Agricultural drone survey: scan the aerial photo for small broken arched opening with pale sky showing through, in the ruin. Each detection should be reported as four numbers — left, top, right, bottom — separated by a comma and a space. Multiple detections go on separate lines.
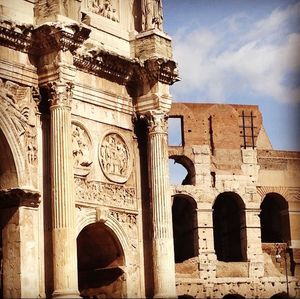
169, 155, 195, 185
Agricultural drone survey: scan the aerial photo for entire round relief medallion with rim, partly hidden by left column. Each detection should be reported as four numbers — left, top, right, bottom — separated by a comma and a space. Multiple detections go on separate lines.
72, 122, 93, 176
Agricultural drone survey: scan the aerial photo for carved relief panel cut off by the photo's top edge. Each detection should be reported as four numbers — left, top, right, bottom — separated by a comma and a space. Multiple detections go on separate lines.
84, 0, 120, 22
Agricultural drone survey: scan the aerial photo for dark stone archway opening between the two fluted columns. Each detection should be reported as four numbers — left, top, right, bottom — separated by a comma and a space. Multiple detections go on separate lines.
77, 222, 126, 298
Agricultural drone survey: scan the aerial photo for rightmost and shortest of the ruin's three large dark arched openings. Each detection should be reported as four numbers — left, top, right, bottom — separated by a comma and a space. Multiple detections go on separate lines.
260, 193, 291, 243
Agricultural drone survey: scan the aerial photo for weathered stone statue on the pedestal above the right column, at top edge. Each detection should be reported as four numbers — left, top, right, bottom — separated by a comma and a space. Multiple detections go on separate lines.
142, 0, 163, 31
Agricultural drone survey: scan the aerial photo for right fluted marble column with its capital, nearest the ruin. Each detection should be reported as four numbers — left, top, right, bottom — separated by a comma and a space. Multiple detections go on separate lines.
147, 111, 176, 298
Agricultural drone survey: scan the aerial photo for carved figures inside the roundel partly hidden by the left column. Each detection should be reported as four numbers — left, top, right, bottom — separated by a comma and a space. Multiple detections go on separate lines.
72, 124, 93, 171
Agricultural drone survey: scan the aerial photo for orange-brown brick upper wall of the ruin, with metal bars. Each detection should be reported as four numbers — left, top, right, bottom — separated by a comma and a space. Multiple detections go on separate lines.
170, 103, 264, 150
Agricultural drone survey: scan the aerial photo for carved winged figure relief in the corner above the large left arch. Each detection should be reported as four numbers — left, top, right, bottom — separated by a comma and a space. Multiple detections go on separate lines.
0, 79, 37, 164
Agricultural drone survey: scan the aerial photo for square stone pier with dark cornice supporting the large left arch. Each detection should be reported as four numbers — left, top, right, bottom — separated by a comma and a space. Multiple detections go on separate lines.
0, 188, 40, 298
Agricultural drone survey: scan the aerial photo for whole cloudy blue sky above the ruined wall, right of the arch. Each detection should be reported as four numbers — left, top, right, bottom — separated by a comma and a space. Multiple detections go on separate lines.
163, 0, 300, 155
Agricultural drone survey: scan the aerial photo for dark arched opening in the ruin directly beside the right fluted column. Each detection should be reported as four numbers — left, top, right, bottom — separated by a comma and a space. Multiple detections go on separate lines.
172, 195, 198, 263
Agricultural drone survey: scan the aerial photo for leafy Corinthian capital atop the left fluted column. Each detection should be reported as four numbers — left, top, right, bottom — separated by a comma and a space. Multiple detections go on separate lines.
47, 81, 74, 107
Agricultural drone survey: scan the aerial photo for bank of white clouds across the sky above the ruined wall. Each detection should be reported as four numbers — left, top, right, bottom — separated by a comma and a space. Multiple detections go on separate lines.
173, 2, 300, 102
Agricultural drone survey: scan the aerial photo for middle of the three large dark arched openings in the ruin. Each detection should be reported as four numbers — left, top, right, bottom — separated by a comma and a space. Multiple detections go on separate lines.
213, 192, 247, 262
